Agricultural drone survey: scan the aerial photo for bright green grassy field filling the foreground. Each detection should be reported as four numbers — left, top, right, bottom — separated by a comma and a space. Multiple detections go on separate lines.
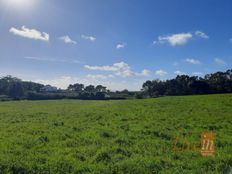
0, 95, 232, 174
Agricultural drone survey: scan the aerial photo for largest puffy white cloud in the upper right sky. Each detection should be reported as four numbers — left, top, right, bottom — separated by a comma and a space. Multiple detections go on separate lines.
153, 33, 193, 46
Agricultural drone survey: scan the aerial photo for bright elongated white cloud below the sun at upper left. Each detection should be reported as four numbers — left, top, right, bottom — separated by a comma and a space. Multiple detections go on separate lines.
9, 26, 49, 41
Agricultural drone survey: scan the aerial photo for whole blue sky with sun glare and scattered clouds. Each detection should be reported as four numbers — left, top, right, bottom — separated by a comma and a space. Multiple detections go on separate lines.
0, 0, 232, 90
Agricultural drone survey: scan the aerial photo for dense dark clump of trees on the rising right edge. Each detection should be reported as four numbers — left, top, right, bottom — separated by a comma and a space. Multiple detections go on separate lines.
141, 69, 232, 98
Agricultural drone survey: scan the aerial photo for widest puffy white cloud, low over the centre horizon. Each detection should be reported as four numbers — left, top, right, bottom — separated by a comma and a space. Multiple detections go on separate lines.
84, 62, 150, 77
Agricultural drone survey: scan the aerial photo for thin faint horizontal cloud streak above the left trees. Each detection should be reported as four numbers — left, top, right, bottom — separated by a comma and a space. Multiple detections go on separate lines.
24, 56, 83, 64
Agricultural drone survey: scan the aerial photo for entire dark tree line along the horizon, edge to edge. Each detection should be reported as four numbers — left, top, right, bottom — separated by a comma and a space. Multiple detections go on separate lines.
0, 70, 232, 100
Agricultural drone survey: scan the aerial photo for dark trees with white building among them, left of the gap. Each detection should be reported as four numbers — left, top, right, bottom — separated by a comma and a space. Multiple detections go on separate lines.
0, 76, 114, 100
